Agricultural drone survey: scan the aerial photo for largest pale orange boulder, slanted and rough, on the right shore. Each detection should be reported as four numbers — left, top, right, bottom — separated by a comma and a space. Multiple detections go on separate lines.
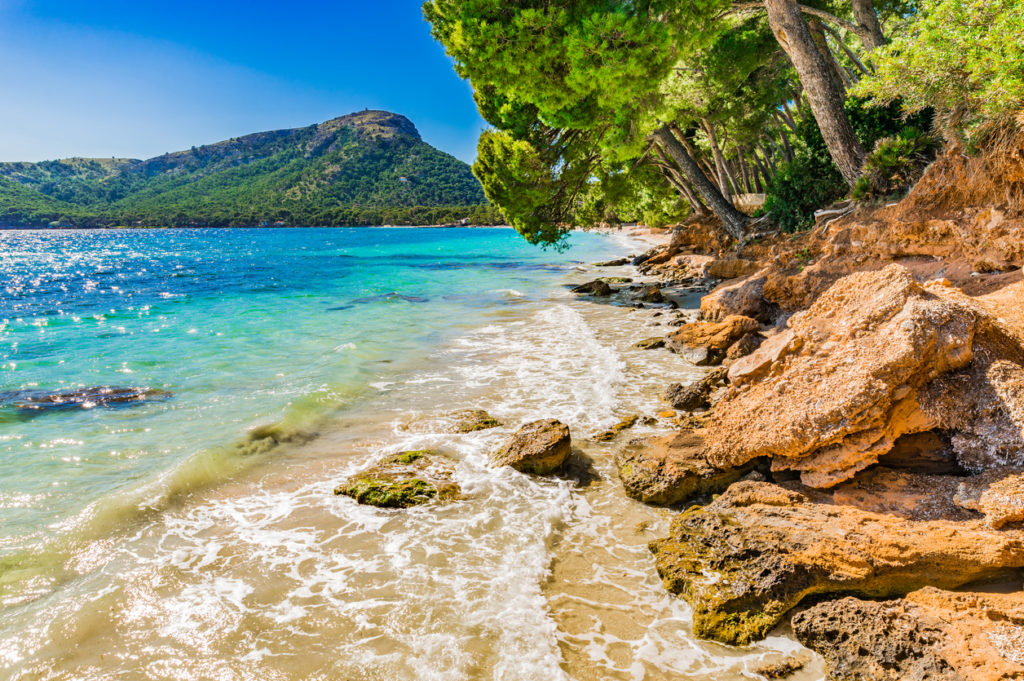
700, 265, 1024, 487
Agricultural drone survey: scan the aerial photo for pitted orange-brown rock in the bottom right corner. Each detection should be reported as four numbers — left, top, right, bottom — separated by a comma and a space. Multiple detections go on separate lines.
793, 588, 1024, 681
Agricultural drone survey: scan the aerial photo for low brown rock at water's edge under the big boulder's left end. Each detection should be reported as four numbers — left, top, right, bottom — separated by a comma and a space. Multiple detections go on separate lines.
615, 433, 754, 506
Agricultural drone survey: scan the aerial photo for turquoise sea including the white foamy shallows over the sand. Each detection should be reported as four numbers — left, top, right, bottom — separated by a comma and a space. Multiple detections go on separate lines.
0, 228, 820, 681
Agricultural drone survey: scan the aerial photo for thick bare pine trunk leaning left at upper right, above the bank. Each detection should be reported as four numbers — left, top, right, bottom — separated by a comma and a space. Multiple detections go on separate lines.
765, 0, 865, 186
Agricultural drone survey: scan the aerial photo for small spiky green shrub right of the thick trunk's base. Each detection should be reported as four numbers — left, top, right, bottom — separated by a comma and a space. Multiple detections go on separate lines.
852, 127, 938, 200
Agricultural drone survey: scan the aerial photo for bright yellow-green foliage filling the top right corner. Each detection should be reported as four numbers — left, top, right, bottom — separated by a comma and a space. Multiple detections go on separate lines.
856, 0, 1024, 136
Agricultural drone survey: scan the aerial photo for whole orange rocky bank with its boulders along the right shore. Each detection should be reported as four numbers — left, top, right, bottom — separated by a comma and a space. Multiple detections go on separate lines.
623, 130, 1024, 681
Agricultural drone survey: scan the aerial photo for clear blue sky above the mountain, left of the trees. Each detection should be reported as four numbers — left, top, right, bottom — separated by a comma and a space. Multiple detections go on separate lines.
0, 0, 484, 161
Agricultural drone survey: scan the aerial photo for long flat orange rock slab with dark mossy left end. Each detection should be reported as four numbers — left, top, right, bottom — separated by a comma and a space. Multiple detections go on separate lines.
650, 481, 1024, 645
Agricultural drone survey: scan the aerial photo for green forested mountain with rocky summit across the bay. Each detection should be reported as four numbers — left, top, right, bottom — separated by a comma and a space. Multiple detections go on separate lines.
0, 111, 498, 226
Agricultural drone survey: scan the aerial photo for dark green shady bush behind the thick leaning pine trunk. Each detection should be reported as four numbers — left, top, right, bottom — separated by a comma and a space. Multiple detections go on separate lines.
764, 98, 932, 231
